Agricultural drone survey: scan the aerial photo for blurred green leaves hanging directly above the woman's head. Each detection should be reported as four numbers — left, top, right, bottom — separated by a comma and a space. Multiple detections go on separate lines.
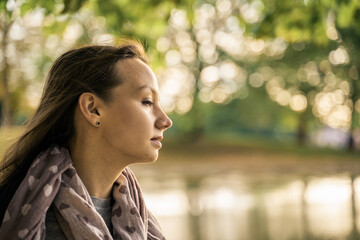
87, 0, 194, 48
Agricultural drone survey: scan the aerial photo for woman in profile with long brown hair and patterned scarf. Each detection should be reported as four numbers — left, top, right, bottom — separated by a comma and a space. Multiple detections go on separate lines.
0, 43, 172, 239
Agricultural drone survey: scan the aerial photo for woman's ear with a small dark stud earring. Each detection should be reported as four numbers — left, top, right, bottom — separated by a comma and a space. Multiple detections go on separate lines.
78, 93, 100, 126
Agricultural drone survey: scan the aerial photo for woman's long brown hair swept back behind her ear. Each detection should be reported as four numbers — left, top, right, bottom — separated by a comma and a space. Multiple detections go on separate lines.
0, 41, 147, 219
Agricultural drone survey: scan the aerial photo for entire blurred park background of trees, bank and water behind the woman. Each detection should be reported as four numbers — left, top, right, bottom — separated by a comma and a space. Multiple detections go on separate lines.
0, 0, 360, 240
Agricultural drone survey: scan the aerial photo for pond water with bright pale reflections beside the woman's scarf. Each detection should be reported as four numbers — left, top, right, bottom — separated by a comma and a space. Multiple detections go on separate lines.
139, 173, 360, 240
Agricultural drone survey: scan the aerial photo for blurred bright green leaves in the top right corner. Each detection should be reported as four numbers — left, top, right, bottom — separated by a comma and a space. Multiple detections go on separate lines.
256, 0, 360, 42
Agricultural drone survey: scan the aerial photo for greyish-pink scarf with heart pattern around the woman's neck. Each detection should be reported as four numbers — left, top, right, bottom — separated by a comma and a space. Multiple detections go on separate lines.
0, 146, 165, 240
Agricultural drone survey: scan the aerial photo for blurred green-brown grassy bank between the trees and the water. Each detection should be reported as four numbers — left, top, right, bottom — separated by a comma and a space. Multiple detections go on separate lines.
0, 127, 360, 175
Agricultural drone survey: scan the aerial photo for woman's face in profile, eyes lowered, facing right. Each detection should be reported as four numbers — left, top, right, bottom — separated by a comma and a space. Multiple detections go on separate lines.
99, 58, 172, 164
